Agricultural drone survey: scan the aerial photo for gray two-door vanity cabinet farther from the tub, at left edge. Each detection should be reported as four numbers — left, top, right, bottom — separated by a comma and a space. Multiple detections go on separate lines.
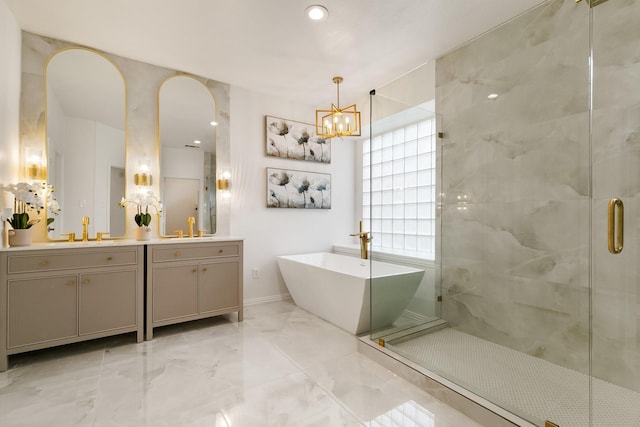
0, 244, 144, 371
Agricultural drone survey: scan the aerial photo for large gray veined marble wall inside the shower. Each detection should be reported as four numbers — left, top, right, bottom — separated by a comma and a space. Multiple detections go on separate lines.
436, 0, 640, 391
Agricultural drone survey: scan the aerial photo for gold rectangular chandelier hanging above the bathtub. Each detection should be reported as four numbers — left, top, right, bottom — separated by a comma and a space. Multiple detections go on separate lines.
316, 77, 360, 139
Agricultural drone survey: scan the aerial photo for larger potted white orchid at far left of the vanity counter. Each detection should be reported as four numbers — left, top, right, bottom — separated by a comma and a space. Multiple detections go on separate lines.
3, 182, 60, 246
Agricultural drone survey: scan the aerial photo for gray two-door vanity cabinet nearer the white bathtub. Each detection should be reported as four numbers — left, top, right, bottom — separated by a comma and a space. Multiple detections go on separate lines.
146, 240, 243, 340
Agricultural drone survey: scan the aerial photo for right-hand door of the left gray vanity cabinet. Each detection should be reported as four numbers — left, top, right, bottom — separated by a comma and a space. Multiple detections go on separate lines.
80, 270, 137, 335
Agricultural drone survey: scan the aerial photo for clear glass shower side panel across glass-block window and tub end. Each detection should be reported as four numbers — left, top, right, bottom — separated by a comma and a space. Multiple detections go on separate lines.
362, 90, 441, 339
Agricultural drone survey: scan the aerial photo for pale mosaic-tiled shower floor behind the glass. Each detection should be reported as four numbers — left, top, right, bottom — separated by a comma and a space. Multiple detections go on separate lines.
387, 328, 640, 427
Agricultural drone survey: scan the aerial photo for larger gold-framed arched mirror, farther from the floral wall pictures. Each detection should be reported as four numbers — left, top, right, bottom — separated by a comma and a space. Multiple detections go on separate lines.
45, 48, 126, 239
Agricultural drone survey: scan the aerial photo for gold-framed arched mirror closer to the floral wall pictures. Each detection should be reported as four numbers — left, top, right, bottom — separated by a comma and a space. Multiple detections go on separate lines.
158, 76, 216, 235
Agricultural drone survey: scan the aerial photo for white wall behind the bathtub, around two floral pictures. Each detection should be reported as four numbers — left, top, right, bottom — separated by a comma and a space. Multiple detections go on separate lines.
230, 87, 357, 303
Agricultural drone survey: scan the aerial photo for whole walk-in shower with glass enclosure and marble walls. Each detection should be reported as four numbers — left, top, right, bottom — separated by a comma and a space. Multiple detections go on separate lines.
363, 0, 640, 427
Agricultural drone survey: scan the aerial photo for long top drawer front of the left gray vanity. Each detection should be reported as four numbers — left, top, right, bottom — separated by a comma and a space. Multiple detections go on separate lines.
7, 249, 138, 274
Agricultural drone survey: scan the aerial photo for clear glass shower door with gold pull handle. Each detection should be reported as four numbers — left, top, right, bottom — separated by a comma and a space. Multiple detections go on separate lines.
591, 0, 640, 427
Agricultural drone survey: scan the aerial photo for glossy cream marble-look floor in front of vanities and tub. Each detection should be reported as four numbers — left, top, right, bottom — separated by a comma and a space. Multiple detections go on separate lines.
0, 301, 479, 427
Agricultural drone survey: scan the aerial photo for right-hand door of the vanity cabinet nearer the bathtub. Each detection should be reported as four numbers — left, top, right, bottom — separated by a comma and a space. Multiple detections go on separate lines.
200, 261, 240, 313
